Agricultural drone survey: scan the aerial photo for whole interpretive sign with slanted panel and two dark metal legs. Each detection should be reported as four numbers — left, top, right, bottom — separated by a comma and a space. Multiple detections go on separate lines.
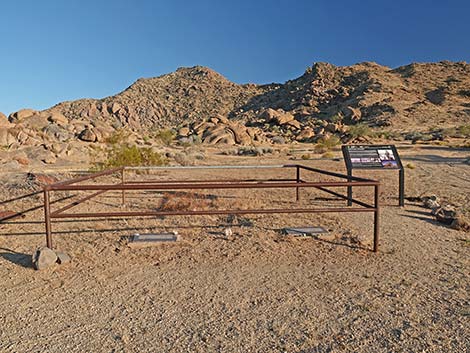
341, 145, 405, 207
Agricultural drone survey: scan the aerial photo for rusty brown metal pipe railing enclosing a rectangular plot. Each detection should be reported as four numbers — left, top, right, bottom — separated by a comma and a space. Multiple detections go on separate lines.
43, 164, 380, 252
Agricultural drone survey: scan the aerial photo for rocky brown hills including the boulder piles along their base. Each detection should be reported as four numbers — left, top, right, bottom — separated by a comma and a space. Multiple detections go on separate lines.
0, 61, 470, 166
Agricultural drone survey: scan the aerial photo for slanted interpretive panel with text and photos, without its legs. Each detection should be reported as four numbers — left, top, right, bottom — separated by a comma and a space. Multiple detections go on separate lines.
342, 145, 403, 169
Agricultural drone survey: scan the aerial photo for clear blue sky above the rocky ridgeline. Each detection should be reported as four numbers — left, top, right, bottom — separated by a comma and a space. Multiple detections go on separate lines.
0, 0, 470, 114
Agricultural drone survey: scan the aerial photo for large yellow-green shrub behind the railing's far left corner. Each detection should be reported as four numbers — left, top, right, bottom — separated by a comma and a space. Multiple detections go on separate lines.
92, 144, 167, 170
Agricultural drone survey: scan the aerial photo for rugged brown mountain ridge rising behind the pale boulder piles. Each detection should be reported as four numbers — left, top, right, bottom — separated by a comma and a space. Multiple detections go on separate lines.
46, 61, 470, 130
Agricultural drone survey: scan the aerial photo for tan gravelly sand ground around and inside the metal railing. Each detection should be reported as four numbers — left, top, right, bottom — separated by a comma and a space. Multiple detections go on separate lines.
0, 144, 470, 352
